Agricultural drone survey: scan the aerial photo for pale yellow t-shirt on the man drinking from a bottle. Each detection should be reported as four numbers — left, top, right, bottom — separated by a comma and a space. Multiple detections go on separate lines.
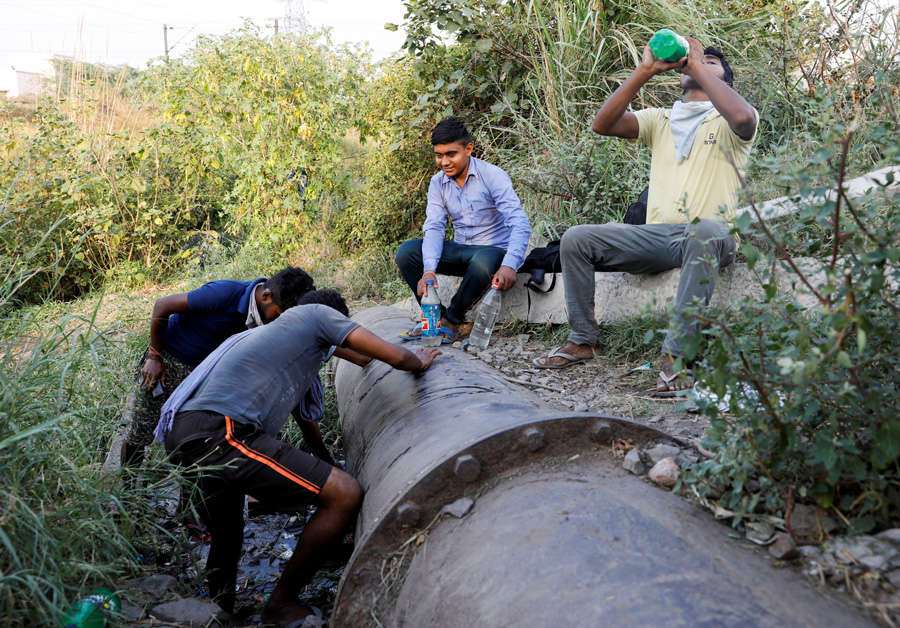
635, 109, 759, 224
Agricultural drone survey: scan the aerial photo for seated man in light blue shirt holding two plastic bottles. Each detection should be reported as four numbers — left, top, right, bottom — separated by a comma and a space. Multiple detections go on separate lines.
396, 118, 531, 339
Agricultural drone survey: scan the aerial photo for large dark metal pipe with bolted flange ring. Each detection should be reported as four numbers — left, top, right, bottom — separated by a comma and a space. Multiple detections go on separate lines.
332, 307, 866, 627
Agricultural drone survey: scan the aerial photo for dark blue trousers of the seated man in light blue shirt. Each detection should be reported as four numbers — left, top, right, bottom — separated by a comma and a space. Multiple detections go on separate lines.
395, 238, 506, 325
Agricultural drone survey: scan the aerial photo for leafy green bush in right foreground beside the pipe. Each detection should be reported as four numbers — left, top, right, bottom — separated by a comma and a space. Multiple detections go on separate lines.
686, 79, 900, 532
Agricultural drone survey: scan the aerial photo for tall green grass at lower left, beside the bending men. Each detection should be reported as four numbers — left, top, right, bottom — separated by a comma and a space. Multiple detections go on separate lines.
0, 298, 142, 626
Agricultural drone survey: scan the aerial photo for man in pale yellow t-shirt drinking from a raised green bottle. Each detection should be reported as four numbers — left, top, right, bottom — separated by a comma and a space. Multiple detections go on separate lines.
534, 37, 759, 396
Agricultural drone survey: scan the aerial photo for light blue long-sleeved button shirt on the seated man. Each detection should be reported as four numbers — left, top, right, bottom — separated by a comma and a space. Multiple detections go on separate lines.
422, 157, 531, 271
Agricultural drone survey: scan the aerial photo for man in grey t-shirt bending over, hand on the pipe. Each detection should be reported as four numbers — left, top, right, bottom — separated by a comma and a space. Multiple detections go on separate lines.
165, 290, 440, 624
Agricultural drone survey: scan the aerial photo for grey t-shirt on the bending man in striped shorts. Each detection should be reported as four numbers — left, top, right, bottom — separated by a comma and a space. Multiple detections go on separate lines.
180, 304, 359, 436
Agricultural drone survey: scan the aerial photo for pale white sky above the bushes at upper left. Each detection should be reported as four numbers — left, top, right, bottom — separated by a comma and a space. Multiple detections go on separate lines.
0, 0, 404, 68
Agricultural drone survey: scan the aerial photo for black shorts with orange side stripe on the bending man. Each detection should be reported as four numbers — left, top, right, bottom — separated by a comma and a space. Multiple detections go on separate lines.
166, 411, 332, 510
